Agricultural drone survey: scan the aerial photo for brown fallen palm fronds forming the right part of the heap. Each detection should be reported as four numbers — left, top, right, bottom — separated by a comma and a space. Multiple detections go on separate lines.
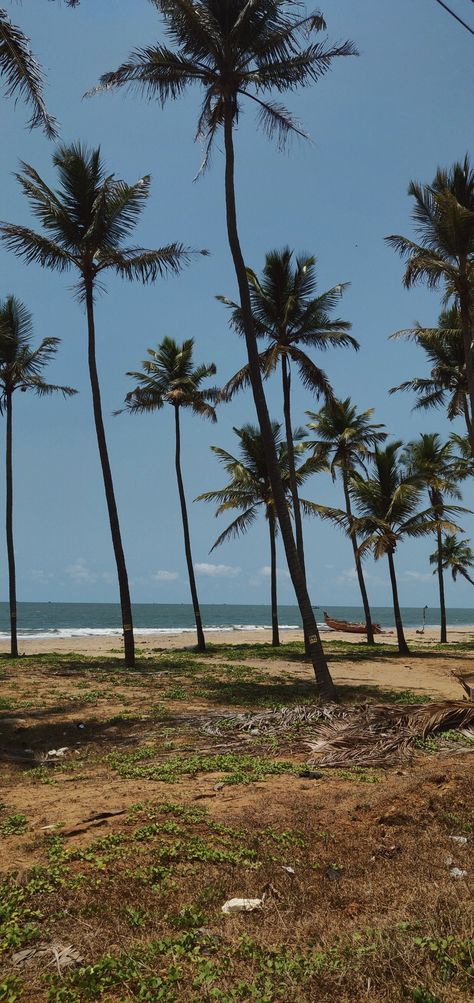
308, 701, 474, 767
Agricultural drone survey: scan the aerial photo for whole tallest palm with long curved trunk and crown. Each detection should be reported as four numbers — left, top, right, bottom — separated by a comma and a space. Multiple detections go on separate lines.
91, 0, 356, 700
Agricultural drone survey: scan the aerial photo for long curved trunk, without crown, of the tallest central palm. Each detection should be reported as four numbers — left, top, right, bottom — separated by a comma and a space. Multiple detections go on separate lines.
224, 99, 337, 700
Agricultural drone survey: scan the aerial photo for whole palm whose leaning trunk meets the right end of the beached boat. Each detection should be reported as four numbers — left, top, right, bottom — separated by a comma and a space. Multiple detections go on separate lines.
307, 397, 387, 644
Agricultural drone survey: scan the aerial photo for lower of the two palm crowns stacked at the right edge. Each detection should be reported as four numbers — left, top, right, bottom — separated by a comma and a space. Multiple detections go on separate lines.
390, 305, 473, 435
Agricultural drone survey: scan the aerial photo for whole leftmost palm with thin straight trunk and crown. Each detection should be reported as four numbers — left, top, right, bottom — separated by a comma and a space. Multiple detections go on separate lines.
0, 296, 77, 658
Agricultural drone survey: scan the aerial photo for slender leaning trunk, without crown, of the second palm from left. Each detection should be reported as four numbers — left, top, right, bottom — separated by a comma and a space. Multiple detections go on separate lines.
84, 277, 135, 668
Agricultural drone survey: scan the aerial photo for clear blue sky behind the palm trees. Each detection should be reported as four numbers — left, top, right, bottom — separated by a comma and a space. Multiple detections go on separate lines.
0, 0, 474, 606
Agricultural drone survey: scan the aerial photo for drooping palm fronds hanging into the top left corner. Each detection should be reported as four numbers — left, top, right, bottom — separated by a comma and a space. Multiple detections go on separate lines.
0, 7, 57, 139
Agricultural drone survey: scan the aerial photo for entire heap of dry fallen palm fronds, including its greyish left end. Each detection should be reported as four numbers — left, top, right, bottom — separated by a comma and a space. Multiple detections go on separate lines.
202, 700, 474, 767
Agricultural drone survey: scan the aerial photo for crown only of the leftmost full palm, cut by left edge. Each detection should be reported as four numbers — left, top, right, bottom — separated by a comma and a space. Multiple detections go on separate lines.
0, 296, 77, 403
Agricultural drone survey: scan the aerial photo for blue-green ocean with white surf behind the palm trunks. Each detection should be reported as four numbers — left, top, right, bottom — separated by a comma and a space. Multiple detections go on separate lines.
0, 603, 474, 639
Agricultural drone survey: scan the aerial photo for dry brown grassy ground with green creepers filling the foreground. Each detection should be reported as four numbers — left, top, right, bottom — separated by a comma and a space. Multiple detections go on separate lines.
0, 645, 474, 1003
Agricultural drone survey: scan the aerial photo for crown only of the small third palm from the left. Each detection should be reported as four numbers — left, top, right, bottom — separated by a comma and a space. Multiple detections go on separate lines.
121, 338, 218, 421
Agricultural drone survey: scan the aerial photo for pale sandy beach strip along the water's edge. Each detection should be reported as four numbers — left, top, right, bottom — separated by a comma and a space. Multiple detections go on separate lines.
0, 624, 474, 657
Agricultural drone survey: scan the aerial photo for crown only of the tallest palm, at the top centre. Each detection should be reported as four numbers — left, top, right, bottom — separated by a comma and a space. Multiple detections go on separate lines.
95, 0, 356, 169
